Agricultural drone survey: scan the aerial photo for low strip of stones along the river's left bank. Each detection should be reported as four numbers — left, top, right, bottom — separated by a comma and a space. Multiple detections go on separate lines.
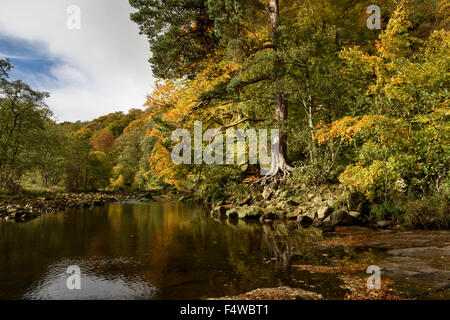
0, 192, 136, 222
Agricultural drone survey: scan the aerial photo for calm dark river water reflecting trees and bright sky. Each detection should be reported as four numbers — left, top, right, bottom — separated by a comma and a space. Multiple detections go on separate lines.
0, 203, 344, 299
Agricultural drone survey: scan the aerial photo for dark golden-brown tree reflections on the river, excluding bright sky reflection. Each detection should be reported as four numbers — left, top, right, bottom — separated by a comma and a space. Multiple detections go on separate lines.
0, 203, 324, 299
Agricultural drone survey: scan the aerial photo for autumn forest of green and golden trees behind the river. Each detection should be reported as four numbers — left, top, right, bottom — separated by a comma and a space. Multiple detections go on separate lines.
0, 0, 450, 228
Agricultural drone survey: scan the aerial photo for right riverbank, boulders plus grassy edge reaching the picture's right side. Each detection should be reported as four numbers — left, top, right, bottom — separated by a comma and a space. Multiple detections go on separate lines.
206, 184, 450, 232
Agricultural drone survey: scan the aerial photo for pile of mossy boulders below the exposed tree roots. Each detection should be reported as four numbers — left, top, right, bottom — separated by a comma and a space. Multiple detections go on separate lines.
211, 187, 396, 232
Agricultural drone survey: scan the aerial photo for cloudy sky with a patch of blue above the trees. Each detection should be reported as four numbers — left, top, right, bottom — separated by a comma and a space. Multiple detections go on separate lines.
0, 0, 154, 122
